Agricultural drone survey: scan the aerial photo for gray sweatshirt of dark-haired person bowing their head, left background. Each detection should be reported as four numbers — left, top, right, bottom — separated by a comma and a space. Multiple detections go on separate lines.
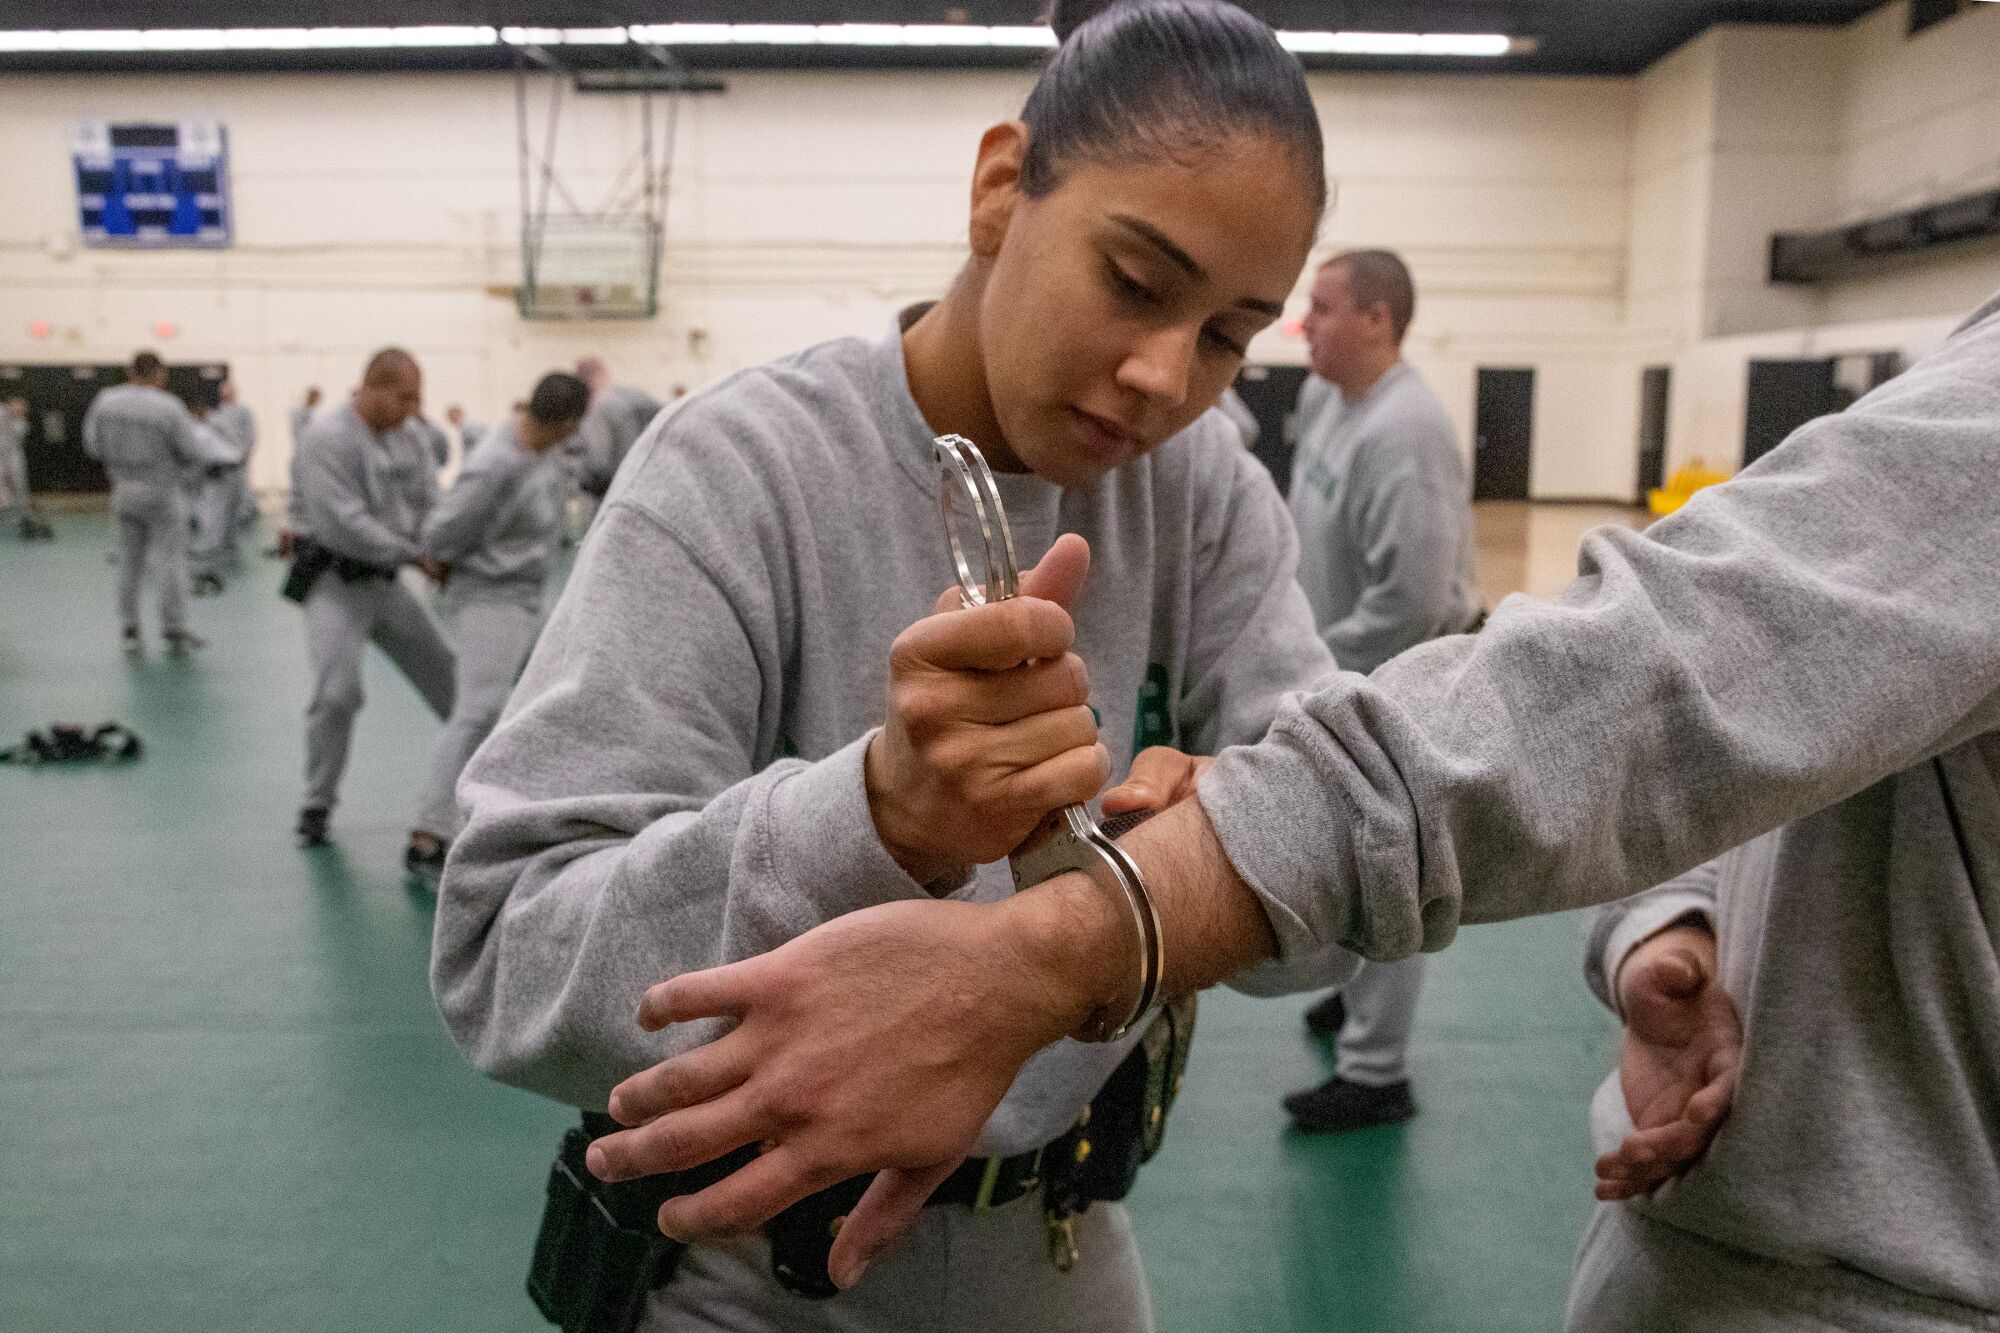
424, 422, 562, 606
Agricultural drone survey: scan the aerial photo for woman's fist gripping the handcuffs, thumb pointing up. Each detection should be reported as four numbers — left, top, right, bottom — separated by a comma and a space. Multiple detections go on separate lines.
866, 536, 1110, 885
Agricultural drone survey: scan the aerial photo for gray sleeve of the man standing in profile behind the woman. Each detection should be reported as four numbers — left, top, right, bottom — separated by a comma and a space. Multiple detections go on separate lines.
1324, 440, 1466, 671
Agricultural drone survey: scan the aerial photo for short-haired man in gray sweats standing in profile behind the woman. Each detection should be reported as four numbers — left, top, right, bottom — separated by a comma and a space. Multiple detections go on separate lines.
1284, 250, 1480, 1133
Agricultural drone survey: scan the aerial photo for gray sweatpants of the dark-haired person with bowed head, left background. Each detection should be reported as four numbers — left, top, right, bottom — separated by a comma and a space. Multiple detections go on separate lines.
416, 588, 542, 843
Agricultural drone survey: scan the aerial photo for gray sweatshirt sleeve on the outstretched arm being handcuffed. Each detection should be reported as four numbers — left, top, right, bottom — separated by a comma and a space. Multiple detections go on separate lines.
1200, 286, 2000, 959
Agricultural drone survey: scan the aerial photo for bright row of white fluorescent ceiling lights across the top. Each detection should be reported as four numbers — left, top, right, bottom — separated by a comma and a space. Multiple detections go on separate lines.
0, 24, 1534, 56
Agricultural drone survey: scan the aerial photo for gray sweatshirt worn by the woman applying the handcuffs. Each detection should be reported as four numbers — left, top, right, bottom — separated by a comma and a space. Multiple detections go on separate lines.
432, 324, 1332, 1153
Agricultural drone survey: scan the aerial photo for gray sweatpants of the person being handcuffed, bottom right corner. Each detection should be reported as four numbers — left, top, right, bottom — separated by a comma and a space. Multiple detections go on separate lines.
1566, 1203, 2000, 1333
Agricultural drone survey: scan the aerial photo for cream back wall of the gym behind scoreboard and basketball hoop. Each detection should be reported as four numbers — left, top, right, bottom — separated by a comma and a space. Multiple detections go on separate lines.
0, 63, 1632, 494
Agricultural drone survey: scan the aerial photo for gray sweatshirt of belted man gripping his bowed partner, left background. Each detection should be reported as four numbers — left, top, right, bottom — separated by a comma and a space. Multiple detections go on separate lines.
292, 402, 438, 568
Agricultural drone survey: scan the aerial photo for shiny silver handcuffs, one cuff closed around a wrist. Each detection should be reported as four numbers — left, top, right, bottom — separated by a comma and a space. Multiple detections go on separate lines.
936, 434, 1166, 1041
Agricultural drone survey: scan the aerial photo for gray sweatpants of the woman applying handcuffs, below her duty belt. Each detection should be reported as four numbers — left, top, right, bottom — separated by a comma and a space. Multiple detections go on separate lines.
640, 1193, 1152, 1333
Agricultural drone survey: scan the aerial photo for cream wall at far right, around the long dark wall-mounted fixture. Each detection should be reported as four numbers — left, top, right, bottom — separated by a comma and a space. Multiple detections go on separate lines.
1634, 0, 2000, 468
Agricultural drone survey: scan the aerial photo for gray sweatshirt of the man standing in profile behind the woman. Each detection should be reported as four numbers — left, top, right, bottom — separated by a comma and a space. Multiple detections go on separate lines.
1290, 360, 1480, 671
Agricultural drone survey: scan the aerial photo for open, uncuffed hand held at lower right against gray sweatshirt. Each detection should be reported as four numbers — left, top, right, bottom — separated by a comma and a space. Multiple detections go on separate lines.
1598, 927, 1744, 1201
